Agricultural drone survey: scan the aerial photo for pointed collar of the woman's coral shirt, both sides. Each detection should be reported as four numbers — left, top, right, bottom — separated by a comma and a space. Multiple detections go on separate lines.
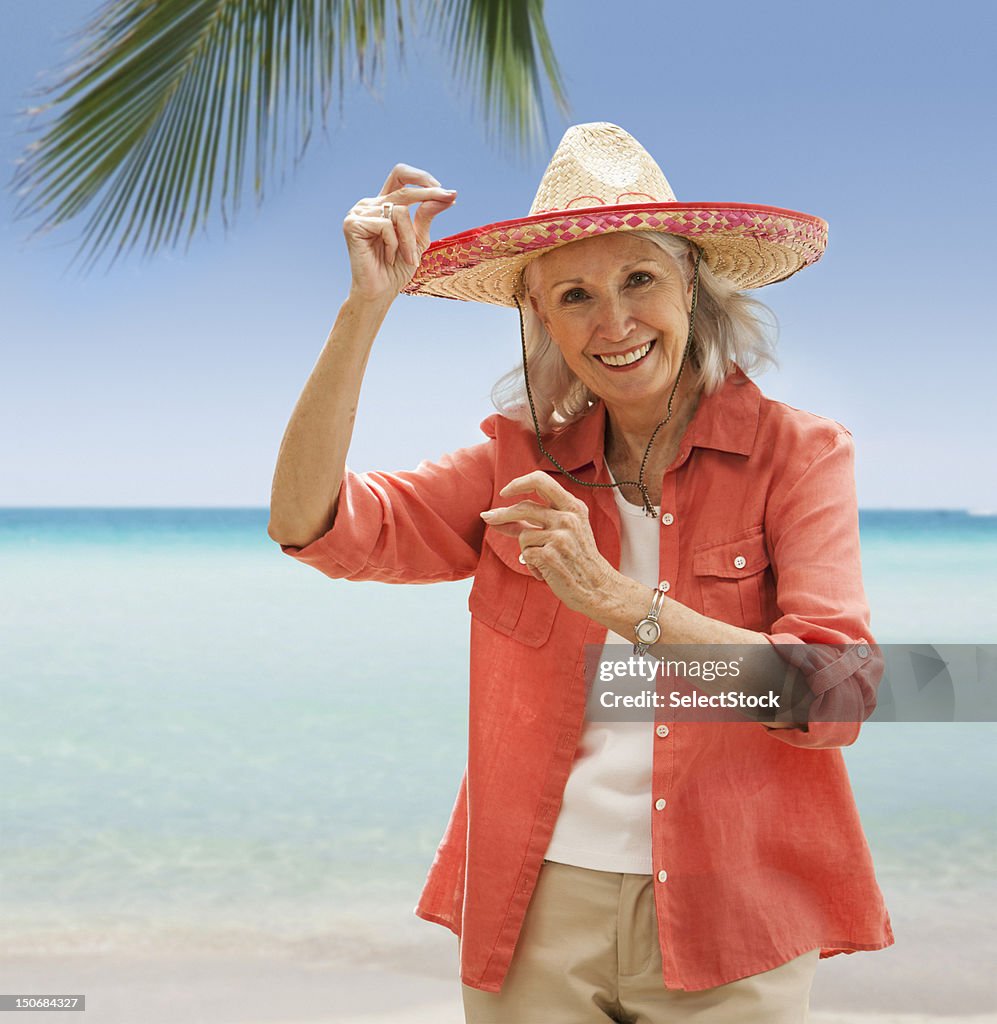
533, 367, 762, 472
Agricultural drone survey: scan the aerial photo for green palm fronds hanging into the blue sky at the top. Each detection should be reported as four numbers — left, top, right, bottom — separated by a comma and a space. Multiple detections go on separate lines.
12, 0, 566, 265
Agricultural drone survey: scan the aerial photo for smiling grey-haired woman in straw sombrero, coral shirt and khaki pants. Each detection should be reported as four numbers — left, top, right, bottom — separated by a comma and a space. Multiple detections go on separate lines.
269, 123, 894, 1024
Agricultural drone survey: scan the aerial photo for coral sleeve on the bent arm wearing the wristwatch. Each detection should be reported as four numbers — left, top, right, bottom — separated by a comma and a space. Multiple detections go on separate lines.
765, 427, 883, 748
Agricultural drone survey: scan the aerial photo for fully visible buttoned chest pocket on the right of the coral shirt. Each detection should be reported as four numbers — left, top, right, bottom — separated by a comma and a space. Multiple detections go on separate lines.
692, 526, 773, 630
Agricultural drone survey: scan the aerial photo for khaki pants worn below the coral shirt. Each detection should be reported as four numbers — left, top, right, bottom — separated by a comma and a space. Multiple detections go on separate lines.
461, 860, 820, 1024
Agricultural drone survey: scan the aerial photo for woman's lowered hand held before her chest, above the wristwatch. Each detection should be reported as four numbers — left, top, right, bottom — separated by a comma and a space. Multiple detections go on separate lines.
481, 470, 616, 611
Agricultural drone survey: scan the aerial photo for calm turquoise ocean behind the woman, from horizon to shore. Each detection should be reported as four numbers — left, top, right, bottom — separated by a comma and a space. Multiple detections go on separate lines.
0, 508, 997, 983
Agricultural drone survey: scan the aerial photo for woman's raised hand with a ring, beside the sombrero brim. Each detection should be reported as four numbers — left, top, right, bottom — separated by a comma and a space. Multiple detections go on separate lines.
343, 164, 457, 301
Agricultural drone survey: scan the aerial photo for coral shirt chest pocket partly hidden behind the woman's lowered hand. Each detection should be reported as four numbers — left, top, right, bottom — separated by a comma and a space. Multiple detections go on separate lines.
468, 529, 561, 647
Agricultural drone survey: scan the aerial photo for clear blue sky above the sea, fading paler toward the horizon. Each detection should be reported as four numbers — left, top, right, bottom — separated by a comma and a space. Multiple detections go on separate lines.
0, 0, 997, 508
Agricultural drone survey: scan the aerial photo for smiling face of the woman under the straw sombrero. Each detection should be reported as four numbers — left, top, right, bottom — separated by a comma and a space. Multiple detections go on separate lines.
526, 231, 692, 422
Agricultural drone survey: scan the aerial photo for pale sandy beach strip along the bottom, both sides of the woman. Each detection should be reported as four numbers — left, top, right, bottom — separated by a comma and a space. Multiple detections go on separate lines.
0, 919, 997, 1024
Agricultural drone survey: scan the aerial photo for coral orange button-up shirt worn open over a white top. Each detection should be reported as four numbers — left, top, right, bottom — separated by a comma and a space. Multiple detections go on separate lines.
281, 370, 894, 992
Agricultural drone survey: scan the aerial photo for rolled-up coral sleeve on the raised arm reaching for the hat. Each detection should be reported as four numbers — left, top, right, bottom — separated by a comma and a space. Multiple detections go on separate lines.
280, 440, 494, 584
